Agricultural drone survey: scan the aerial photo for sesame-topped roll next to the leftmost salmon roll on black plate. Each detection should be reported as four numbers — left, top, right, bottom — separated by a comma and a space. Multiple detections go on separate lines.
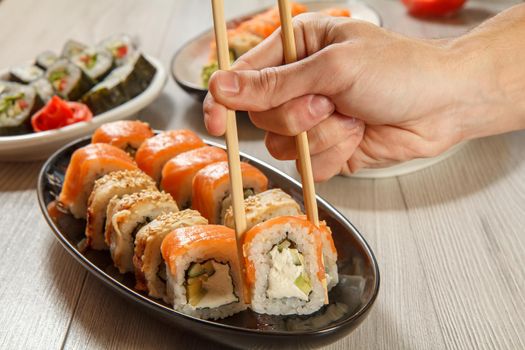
86, 170, 157, 250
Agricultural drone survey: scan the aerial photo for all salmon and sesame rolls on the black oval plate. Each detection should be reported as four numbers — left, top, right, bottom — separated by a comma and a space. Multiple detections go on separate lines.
56, 120, 339, 319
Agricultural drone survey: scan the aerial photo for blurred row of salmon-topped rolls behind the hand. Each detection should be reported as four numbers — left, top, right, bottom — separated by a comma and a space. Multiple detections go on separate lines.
201, 2, 351, 87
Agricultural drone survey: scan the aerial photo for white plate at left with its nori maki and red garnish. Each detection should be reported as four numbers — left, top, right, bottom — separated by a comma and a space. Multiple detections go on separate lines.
0, 34, 167, 161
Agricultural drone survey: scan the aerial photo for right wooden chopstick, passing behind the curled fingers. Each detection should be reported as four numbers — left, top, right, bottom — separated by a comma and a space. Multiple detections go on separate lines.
278, 0, 328, 304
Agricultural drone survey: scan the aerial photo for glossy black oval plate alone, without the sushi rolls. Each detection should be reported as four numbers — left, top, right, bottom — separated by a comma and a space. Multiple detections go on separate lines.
37, 137, 379, 348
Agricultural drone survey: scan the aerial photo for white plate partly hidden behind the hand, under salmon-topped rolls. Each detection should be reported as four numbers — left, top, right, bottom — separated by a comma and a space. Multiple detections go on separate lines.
171, 0, 381, 101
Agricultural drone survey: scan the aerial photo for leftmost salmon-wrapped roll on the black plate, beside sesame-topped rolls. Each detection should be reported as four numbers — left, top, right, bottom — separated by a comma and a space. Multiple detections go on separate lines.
58, 143, 137, 218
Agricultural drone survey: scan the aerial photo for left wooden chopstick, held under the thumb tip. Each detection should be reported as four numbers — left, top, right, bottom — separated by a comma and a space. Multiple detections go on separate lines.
211, 0, 250, 303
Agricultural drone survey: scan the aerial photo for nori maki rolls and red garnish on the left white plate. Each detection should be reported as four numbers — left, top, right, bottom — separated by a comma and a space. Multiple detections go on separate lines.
0, 34, 156, 136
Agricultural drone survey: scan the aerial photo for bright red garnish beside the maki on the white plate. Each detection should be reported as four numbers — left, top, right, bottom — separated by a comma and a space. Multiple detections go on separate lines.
31, 96, 93, 132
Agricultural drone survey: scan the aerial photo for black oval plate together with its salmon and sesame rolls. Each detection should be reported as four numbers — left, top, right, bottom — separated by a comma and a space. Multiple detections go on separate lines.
37, 120, 379, 348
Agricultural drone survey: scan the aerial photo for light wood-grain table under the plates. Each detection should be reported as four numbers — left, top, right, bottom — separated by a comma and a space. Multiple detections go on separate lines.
0, 0, 525, 349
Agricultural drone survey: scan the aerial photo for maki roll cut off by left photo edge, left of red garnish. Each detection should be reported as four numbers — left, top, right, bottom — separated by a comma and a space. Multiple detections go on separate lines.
0, 81, 39, 135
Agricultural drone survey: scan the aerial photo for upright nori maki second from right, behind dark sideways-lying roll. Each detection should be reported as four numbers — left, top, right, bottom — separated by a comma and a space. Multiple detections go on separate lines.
70, 49, 113, 81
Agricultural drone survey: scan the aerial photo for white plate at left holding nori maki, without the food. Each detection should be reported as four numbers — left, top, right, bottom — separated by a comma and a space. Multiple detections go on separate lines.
0, 56, 167, 161
